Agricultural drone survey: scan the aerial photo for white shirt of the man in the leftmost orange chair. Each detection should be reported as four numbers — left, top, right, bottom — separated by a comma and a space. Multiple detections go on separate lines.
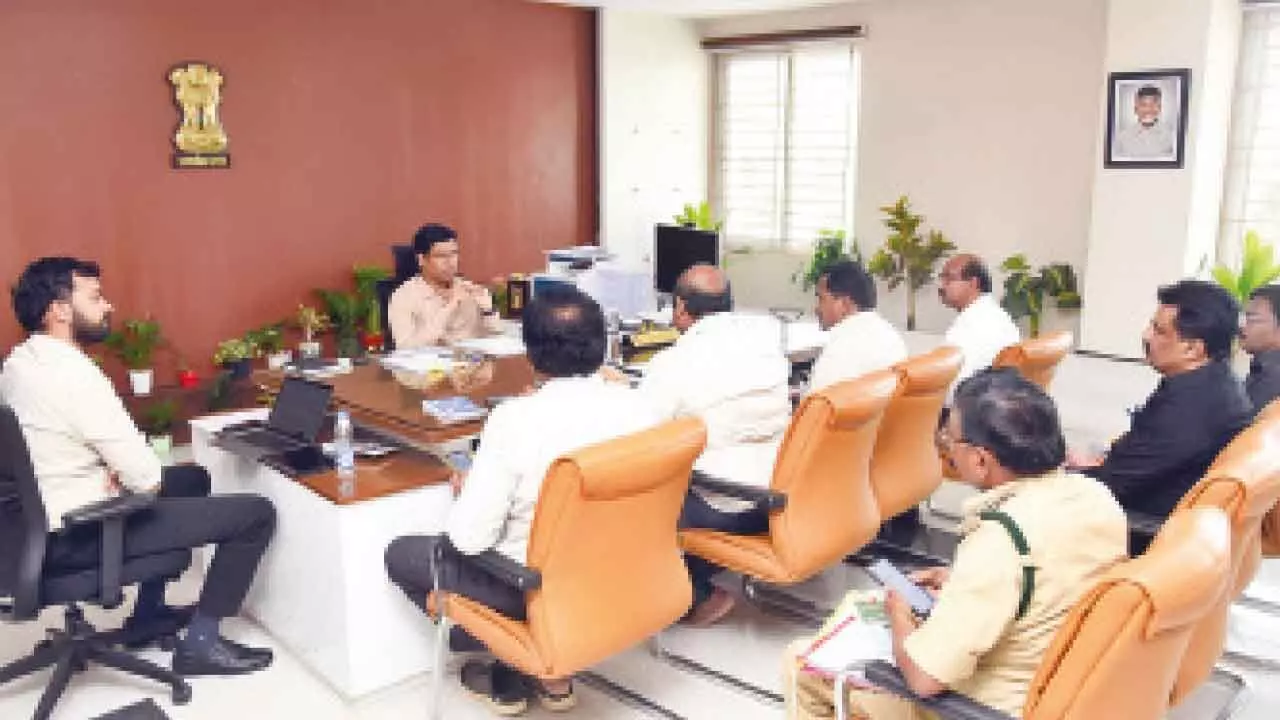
448, 375, 660, 564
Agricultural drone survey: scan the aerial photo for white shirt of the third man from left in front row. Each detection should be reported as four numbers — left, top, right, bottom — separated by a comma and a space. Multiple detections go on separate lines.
809, 310, 906, 392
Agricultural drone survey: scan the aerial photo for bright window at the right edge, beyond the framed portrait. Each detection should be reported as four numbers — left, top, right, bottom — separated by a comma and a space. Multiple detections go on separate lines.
1219, 6, 1280, 265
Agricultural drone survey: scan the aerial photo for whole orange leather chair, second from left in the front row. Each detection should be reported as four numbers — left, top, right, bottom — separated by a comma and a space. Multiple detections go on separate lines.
680, 370, 899, 584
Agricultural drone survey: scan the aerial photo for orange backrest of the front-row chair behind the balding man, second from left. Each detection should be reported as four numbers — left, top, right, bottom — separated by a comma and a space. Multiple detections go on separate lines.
769, 370, 899, 582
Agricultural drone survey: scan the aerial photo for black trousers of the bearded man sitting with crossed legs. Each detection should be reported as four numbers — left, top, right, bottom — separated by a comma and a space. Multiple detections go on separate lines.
45, 465, 275, 618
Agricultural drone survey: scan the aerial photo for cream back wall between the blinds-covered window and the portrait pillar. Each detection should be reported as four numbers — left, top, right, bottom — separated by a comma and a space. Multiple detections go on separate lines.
700, 0, 1107, 329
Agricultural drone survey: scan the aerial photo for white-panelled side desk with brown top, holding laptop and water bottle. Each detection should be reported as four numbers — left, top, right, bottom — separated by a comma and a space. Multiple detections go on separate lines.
191, 409, 453, 698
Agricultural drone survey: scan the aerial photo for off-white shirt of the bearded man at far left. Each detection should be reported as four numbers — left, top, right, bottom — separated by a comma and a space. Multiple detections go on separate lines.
0, 333, 161, 530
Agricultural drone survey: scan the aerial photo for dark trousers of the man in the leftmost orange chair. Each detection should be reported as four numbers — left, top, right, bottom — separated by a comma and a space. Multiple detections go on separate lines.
384, 536, 526, 651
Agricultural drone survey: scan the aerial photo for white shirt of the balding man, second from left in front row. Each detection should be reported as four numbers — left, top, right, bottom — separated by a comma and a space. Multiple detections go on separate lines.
640, 313, 791, 511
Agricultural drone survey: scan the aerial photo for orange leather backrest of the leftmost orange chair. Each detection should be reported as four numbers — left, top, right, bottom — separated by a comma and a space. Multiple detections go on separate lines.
519, 419, 707, 678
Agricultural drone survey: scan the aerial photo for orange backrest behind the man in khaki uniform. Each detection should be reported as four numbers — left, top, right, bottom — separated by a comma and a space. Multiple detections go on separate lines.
1023, 507, 1231, 720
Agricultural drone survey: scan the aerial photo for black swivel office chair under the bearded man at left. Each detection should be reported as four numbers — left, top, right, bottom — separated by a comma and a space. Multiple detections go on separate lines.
0, 406, 191, 720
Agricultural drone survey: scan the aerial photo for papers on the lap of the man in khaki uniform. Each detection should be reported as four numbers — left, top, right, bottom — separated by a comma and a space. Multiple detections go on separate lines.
800, 591, 893, 683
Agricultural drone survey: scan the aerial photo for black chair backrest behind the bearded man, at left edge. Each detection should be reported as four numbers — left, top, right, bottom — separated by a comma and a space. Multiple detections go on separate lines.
0, 405, 49, 620
